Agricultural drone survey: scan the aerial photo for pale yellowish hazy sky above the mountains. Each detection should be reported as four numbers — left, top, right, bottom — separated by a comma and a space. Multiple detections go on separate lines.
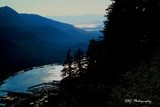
0, 0, 110, 16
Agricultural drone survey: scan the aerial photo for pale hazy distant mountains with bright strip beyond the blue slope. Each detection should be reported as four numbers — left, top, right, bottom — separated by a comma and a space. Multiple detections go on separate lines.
46, 14, 104, 31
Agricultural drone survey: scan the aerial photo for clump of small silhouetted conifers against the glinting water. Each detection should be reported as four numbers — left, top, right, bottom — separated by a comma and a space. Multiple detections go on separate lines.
62, 48, 88, 78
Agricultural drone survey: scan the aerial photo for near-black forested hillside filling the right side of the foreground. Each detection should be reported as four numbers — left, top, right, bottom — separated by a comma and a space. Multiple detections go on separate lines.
49, 0, 160, 107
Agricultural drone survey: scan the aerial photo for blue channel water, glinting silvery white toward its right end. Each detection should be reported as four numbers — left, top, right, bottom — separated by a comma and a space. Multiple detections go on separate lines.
0, 64, 63, 96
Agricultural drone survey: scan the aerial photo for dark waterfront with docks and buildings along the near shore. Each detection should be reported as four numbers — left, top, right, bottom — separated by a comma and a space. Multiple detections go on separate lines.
0, 80, 60, 106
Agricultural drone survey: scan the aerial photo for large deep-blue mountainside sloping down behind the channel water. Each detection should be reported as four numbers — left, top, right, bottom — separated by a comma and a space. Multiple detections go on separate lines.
0, 6, 102, 79
